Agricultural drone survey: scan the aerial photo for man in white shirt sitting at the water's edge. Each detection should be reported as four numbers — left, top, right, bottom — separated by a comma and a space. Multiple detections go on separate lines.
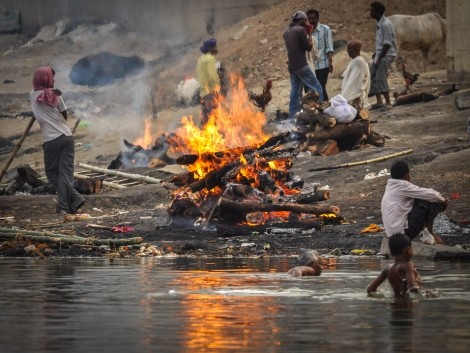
381, 161, 447, 244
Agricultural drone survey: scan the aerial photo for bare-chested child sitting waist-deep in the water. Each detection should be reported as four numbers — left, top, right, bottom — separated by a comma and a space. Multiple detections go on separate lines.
367, 233, 435, 298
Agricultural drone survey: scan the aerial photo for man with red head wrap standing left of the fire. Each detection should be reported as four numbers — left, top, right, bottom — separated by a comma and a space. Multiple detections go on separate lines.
30, 67, 85, 215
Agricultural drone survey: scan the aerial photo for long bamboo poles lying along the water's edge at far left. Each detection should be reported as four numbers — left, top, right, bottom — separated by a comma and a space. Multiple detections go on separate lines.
0, 227, 143, 246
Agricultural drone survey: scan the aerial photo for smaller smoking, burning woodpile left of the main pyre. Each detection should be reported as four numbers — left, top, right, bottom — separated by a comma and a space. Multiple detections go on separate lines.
108, 134, 175, 169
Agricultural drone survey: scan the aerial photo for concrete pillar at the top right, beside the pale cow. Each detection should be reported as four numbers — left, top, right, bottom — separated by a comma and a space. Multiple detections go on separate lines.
446, 0, 470, 82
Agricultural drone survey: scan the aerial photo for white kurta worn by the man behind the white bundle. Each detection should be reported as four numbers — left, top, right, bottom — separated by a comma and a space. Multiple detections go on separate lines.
341, 55, 370, 106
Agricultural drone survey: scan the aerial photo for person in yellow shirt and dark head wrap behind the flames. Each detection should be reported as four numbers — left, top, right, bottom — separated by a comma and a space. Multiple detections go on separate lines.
196, 38, 220, 127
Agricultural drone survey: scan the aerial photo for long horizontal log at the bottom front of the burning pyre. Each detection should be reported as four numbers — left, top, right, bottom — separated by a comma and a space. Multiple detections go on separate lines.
219, 198, 340, 215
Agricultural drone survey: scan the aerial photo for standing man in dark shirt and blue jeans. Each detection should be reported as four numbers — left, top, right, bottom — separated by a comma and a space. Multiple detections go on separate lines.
283, 11, 323, 118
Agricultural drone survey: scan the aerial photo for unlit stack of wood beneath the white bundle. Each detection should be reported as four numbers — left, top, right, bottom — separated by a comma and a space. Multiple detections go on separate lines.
296, 92, 385, 156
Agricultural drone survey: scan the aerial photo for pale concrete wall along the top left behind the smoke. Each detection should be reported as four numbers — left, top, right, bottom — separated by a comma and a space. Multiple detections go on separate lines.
0, 0, 278, 39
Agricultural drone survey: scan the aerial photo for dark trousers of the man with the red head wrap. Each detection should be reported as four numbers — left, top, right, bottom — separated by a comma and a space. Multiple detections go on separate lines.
44, 135, 85, 213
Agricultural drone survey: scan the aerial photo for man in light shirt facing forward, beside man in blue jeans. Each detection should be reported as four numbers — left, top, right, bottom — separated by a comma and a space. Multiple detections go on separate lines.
307, 10, 334, 101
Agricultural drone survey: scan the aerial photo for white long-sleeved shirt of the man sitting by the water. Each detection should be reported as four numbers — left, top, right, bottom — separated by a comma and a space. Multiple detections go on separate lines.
381, 179, 445, 237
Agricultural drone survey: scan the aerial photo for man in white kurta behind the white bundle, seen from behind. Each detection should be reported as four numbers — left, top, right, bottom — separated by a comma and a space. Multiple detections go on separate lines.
341, 40, 370, 108
